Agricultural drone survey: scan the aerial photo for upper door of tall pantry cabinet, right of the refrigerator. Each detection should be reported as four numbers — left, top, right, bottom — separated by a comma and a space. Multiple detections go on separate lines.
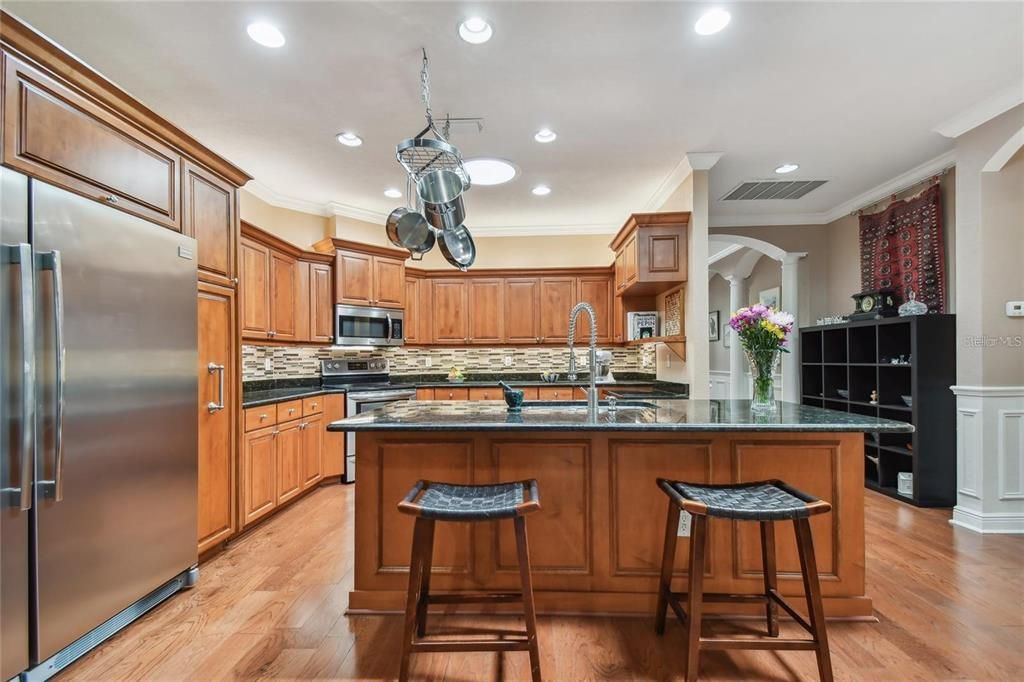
181, 161, 239, 286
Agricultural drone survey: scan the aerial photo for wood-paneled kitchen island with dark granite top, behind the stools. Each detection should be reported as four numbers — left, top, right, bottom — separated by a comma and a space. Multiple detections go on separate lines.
328, 400, 912, 619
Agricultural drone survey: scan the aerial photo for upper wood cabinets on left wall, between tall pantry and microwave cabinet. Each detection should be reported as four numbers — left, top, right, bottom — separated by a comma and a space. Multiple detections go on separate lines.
240, 223, 334, 343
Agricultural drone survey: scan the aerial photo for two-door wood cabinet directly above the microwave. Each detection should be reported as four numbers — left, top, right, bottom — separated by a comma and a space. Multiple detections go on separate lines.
335, 250, 406, 308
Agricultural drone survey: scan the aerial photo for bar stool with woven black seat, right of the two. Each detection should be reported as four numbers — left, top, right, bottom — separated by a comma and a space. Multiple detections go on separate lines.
654, 478, 833, 682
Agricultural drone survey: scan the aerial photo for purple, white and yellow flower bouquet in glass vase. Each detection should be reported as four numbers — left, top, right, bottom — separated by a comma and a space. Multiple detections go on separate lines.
729, 304, 794, 414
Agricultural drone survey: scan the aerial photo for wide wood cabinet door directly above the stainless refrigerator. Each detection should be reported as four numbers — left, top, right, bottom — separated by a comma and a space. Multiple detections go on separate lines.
3, 54, 181, 231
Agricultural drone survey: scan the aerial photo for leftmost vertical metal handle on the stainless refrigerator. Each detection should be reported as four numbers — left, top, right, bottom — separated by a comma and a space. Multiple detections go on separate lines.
4, 243, 36, 511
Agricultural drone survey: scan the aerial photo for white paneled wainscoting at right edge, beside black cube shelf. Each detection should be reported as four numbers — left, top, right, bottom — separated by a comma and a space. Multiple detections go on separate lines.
950, 386, 1024, 534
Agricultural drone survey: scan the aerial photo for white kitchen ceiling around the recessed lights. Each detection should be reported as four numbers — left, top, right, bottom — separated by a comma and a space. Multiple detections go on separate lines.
4, 2, 1024, 231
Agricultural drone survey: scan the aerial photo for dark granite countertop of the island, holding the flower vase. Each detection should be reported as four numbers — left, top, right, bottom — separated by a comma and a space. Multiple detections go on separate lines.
327, 399, 913, 433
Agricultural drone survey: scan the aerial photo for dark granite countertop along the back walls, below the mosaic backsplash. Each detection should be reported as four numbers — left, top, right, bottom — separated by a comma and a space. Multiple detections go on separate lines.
242, 373, 688, 408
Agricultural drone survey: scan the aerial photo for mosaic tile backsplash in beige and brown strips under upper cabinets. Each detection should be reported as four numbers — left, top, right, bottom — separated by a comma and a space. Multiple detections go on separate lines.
242, 345, 655, 381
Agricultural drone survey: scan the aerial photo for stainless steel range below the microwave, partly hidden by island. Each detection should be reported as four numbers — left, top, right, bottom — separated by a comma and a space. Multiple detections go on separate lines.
321, 358, 416, 483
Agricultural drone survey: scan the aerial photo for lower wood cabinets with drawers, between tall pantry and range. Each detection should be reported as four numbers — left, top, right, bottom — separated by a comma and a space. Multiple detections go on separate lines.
242, 403, 325, 525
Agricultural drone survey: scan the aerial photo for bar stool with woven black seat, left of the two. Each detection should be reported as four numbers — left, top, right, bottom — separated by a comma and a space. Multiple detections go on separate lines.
398, 480, 541, 682
